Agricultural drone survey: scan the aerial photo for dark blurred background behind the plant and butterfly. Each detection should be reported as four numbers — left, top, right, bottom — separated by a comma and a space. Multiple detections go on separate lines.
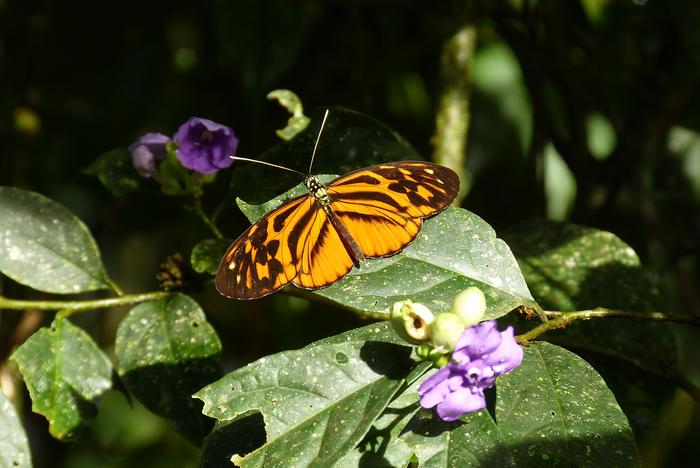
0, 0, 700, 467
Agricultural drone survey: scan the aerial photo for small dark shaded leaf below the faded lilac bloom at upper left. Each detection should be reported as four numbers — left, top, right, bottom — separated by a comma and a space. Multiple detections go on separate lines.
83, 148, 141, 197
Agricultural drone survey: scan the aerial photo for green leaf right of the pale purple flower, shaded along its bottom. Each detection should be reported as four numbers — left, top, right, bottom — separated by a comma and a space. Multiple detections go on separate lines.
496, 342, 640, 466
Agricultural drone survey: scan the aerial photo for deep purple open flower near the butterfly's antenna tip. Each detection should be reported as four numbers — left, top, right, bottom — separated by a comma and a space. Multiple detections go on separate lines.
173, 117, 238, 174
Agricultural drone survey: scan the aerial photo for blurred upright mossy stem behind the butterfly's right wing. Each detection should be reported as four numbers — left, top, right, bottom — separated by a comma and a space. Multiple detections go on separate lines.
432, 22, 476, 205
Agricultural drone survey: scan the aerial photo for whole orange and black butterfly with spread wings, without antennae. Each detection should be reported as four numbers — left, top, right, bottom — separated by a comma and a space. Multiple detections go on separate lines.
216, 161, 459, 299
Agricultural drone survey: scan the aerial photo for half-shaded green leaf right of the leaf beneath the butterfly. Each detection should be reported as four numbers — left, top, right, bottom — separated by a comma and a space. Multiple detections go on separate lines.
503, 220, 658, 310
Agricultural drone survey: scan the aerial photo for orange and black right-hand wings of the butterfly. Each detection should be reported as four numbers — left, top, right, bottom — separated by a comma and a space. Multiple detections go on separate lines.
328, 161, 459, 258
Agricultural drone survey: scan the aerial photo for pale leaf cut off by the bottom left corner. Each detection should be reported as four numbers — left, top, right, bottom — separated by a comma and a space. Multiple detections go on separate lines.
0, 392, 32, 468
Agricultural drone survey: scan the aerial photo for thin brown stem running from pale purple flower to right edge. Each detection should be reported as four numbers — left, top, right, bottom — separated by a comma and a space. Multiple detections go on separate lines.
517, 307, 700, 344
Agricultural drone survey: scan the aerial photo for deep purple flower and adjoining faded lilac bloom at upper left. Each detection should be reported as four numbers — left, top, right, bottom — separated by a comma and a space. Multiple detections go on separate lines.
129, 117, 238, 177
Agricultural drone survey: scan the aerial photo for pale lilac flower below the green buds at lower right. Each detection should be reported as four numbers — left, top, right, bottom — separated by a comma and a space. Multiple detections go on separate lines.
418, 320, 523, 421
